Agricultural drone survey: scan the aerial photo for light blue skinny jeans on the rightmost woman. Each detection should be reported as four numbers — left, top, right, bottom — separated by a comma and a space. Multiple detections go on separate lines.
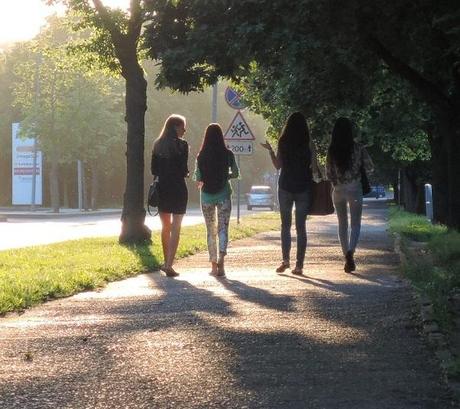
332, 181, 363, 255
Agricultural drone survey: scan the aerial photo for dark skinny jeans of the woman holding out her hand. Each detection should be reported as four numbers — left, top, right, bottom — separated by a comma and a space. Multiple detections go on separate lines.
278, 188, 311, 268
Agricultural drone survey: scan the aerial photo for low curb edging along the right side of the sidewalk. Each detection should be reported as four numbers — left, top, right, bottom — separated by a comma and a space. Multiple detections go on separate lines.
393, 233, 460, 400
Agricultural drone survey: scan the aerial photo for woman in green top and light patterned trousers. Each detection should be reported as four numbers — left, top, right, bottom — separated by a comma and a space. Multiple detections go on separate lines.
195, 124, 239, 276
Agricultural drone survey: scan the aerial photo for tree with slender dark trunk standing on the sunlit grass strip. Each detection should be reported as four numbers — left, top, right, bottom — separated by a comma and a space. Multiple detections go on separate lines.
48, 0, 151, 243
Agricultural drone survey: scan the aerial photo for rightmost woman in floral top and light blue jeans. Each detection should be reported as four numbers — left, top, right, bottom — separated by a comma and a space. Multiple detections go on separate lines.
326, 118, 374, 273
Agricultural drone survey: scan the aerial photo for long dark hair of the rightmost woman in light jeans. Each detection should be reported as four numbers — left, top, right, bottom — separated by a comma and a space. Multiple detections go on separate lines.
328, 117, 355, 173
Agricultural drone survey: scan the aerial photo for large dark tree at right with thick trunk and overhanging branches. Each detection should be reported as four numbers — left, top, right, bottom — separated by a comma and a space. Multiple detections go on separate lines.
146, 0, 460, 227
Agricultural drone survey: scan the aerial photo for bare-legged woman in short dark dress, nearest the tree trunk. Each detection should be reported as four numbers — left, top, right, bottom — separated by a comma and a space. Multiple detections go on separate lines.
151, 114, 188, 277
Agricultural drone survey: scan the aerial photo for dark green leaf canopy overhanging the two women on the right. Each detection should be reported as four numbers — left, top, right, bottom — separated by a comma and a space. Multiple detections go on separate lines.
145, 0, 460, 201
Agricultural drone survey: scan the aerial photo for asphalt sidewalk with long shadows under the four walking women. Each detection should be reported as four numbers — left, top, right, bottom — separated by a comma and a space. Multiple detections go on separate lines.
0, 202, 457, 409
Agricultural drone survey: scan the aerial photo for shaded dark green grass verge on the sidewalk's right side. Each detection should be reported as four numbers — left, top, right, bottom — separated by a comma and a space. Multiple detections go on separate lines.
390, 207, 460, 331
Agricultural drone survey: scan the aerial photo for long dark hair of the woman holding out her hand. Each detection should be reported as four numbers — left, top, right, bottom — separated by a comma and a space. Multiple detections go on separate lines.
278, 112, 311, 166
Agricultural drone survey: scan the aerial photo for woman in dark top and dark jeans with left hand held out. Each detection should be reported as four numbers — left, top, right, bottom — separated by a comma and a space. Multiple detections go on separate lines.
261, 112, 321, 275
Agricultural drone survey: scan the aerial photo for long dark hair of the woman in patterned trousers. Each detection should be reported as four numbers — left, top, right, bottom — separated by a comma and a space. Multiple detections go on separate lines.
197, 124, 232, 193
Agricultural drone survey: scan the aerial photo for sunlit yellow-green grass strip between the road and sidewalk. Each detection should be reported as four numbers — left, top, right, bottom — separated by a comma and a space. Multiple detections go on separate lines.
0, 213, 279, 314
